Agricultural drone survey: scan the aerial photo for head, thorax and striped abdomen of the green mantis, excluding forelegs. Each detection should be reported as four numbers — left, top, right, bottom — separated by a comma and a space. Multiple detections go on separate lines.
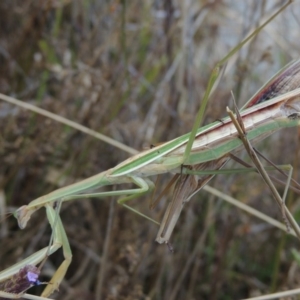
16, 73, 300, 243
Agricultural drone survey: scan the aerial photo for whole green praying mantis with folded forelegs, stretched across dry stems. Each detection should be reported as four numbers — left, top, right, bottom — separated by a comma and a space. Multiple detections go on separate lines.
0, 0, 299, 299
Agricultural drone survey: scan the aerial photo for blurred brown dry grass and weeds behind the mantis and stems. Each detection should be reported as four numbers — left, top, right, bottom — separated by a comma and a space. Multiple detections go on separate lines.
0, 0, 300, 300
